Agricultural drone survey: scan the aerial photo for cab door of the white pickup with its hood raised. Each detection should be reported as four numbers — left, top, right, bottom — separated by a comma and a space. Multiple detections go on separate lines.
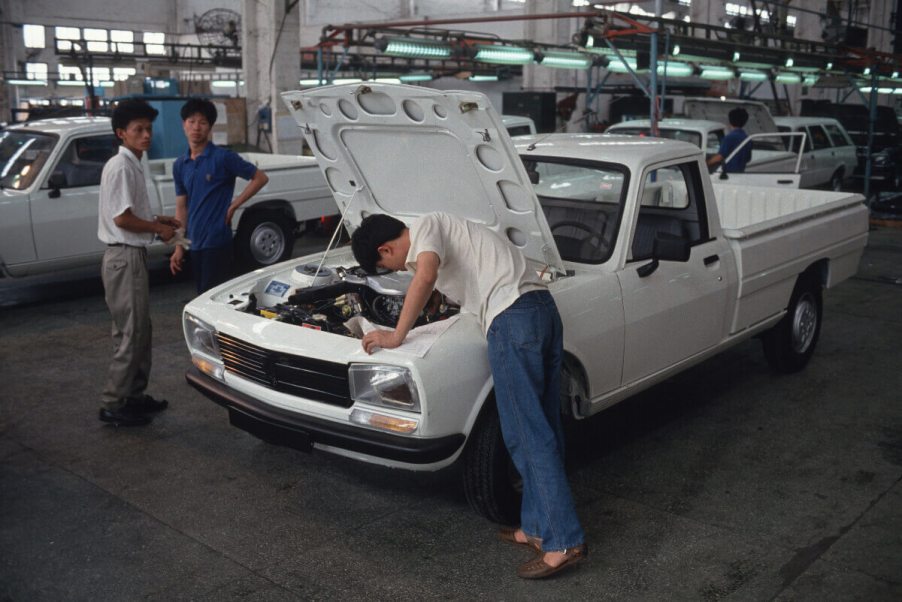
619, 161, 733, 385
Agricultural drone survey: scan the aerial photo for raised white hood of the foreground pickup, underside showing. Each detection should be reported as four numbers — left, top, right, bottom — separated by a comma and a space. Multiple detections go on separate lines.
282, 83, 565, 273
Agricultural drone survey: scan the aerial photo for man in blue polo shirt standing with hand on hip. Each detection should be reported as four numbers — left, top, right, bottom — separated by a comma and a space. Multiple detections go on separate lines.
169, 98, 269, 294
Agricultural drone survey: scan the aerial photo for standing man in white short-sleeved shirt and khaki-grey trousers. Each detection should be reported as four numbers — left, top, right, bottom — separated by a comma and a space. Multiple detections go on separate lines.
97, 100, 179, 426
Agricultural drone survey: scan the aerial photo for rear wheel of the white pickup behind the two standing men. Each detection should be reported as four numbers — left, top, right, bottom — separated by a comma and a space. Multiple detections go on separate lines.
235, 210, 294, 268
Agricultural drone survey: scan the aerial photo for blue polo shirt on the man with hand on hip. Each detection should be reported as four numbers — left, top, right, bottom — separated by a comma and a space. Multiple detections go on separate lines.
172, 142, 257, 251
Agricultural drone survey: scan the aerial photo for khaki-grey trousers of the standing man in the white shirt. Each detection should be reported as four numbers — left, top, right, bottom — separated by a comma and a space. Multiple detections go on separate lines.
101, 245, 151, 409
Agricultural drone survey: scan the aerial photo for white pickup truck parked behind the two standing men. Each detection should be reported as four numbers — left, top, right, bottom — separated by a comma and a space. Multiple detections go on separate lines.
0, 117, 336, 277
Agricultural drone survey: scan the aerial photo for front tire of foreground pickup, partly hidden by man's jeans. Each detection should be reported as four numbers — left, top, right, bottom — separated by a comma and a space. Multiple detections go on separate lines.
463, 403, 523, 525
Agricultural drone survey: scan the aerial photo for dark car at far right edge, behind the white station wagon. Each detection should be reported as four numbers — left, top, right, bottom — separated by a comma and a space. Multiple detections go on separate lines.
801, 101, 902, 191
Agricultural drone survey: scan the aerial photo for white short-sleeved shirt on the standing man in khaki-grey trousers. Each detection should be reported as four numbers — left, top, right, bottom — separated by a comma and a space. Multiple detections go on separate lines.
97, 146, 153, 247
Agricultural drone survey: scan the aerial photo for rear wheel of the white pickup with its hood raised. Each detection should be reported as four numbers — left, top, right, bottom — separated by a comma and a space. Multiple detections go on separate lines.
761, 274, 823, 374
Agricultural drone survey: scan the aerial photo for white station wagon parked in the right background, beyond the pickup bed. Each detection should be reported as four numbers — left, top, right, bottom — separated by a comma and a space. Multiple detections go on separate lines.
774, 117, 858, 190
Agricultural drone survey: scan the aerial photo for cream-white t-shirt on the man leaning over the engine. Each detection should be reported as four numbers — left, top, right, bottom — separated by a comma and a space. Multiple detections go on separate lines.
406, 213, 547, 333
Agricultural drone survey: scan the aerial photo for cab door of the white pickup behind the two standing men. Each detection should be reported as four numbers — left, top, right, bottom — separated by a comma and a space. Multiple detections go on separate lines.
31, 133, 118, 261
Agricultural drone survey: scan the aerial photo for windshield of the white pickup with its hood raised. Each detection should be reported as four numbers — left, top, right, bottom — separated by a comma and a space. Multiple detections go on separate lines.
523, 157, 628, 263
